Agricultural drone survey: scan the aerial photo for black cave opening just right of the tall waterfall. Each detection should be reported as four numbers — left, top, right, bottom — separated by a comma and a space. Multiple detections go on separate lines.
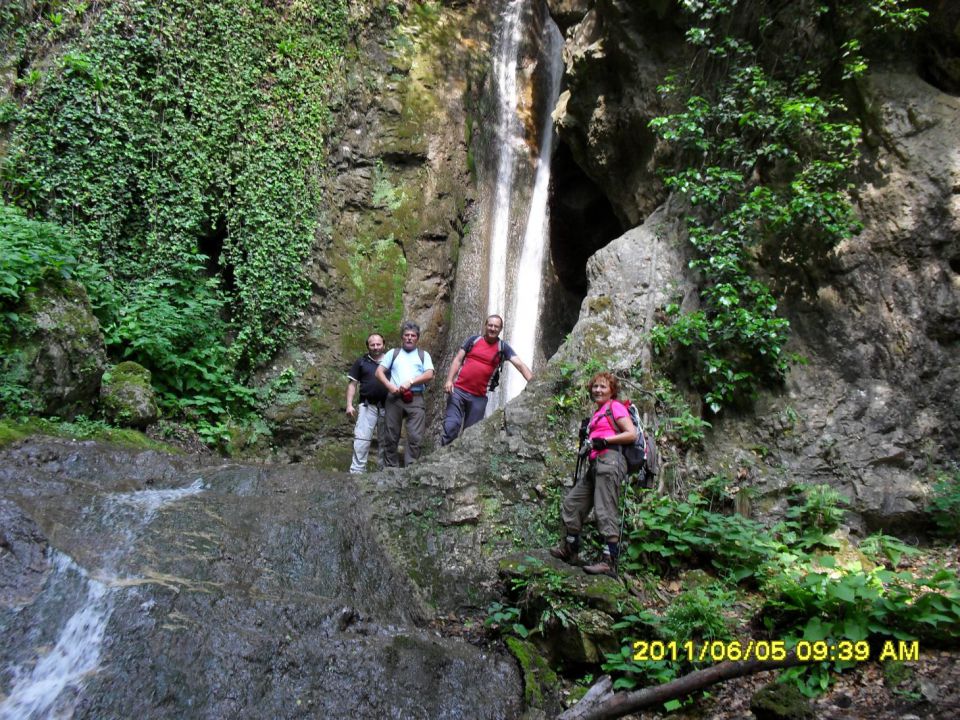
542, 140, 627, 357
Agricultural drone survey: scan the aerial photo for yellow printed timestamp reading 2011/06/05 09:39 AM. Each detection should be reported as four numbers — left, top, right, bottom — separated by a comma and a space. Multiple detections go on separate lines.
633, 640, 920, 663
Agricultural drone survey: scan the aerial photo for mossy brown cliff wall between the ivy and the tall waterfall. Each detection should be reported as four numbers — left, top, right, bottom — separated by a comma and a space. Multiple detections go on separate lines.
258, 5, 489, 462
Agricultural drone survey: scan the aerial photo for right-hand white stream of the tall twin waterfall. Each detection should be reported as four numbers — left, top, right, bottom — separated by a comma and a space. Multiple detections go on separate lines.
503, 17, 563, 401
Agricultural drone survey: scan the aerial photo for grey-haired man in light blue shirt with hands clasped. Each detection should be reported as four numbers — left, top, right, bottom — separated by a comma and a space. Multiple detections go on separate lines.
377, 321, 433, 467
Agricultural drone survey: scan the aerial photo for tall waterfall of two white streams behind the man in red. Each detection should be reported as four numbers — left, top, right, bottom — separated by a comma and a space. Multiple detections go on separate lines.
487, 0, 563, 404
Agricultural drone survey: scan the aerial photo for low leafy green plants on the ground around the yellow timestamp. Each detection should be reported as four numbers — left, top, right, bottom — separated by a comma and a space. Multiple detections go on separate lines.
605, 486, 960, 694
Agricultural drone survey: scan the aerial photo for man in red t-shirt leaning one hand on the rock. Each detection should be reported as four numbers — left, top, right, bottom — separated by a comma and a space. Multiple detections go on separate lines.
440, 315, 533, 445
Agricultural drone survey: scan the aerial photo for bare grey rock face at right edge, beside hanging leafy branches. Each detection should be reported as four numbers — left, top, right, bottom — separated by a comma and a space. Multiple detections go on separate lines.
710, 73, 960, 529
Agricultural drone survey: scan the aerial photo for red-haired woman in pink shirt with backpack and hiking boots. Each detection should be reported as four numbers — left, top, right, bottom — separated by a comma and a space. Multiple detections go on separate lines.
550, 372, 637, 577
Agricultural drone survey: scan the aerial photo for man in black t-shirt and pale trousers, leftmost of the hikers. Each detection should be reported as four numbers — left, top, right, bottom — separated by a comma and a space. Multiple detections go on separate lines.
347, 333, 387, 473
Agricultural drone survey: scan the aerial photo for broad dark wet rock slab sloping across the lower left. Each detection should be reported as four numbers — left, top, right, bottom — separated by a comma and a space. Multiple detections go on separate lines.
0, 441, 522, 718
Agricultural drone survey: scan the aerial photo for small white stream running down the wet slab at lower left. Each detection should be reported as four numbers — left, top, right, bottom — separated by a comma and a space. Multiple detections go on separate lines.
0, 479, 204, 720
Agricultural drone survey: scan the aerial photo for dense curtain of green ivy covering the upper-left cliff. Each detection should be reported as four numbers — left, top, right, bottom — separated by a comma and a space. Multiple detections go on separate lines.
2, 0, 347, 369
